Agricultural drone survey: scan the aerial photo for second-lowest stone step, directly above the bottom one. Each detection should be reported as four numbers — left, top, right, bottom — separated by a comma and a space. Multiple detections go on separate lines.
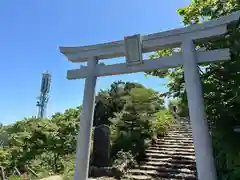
140, 161, 196, 171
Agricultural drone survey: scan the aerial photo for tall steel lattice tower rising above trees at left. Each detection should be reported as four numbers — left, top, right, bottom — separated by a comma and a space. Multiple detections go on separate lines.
37, 72, 51, 118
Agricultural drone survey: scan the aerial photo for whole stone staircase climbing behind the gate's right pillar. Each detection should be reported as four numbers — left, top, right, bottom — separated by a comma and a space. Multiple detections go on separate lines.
124, 118, 197, 180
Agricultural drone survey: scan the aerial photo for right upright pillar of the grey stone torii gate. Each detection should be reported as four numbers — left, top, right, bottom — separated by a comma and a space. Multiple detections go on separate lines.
181, 40, 217, 180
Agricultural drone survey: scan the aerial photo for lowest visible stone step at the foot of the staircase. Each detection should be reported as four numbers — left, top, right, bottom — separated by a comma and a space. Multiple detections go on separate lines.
126, 169, 196, 180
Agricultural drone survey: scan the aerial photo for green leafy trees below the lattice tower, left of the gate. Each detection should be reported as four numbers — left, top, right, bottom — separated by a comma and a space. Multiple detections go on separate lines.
0, 107, 81, 176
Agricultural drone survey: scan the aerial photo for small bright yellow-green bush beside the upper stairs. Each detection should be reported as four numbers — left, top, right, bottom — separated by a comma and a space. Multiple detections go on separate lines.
151, 110, 173, 137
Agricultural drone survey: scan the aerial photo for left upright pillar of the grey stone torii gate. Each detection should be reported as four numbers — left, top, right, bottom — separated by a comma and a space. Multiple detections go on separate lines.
74, 57, 97, 180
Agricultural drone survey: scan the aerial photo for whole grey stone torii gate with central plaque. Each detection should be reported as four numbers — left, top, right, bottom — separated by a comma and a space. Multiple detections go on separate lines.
60, 11, 240, 180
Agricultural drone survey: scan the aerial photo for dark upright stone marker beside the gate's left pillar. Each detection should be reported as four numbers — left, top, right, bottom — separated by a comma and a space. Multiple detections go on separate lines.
92, 124, 110, 167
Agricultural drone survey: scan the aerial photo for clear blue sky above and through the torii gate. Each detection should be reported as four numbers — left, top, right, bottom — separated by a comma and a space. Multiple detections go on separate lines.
0, 0, 190, 124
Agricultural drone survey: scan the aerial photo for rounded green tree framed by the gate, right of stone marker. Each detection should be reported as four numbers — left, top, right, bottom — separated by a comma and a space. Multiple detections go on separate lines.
111, 88, 164, 159
